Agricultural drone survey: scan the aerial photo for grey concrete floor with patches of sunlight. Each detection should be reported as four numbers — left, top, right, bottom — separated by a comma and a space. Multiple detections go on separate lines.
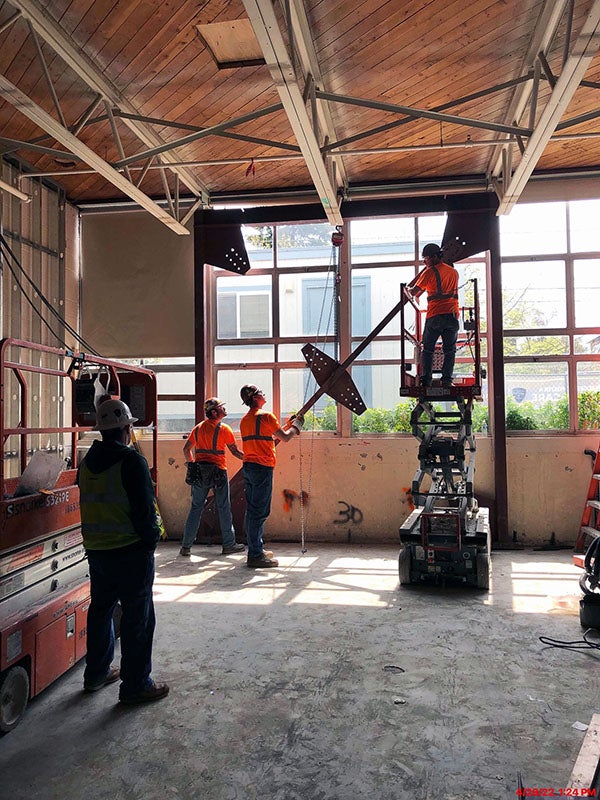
0, 542, 600, 800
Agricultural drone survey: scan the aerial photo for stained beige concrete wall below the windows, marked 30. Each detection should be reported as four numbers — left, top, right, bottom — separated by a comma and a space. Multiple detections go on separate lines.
143, 432, 598, 545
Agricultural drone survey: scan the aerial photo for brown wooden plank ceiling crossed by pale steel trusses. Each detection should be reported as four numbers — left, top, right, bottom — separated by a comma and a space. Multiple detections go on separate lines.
0, 0, 600, 230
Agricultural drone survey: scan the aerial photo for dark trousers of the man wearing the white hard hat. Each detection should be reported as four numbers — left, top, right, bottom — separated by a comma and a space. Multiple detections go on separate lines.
83, 548, 156, 696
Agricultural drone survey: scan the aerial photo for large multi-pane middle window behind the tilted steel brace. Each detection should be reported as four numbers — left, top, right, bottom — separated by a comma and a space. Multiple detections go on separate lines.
207, 214, 487, 433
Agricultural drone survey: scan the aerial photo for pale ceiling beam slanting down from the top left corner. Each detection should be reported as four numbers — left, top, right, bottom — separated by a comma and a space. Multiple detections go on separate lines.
5, 0, 210, 204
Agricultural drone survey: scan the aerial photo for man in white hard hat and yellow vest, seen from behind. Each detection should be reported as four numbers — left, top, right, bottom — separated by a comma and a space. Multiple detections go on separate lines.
77, 399, 169, 705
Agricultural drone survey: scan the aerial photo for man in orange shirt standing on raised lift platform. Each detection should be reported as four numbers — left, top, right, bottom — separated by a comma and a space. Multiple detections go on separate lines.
407, 244, 459, 388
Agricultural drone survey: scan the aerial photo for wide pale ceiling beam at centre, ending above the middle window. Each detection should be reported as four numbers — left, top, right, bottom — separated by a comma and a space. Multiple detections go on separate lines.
243, 0, 343, 225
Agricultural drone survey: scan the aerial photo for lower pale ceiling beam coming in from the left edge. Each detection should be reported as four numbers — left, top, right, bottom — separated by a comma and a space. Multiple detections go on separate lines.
0, 75, 189, 235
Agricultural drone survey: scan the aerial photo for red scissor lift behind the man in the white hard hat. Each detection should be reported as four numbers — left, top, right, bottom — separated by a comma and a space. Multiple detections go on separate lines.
0, 339, 157, 733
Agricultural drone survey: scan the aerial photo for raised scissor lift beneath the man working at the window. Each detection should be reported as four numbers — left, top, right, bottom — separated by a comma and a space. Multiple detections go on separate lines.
398, 281, 491, 589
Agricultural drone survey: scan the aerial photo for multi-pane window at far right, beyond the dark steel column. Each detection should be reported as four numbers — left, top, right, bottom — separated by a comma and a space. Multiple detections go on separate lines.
500, 200, 600, 431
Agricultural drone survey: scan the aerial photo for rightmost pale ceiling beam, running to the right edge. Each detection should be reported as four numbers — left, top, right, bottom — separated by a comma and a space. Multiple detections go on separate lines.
497, 0, 600, 214
